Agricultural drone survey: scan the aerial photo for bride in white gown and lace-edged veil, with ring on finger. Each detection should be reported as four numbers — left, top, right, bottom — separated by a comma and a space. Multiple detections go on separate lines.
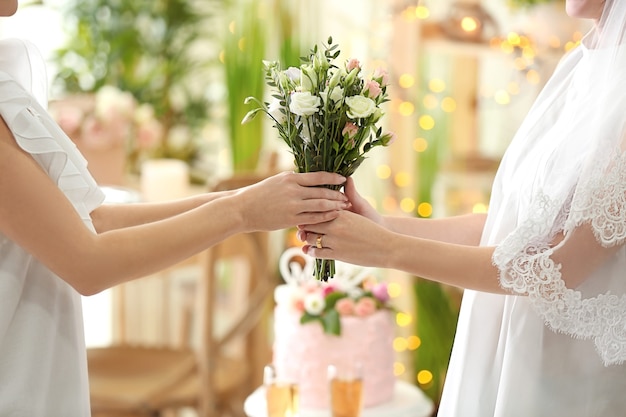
300, 0, 626, 417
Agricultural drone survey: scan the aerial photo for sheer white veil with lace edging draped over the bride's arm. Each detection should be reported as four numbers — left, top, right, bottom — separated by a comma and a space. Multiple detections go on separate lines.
490, 0, 626, 366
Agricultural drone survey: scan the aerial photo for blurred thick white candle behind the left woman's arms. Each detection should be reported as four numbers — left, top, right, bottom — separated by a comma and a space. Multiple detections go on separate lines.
141, 159, 189, 201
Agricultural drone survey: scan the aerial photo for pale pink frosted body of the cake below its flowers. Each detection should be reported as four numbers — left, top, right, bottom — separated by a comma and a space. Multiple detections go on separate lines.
273, 306, 395, 409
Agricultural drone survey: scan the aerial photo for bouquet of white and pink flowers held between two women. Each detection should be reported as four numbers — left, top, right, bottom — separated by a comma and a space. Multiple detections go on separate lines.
242, 37, 394, 281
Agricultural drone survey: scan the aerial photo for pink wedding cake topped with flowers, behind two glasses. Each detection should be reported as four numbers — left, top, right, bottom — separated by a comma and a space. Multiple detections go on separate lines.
273, 248, 395, 409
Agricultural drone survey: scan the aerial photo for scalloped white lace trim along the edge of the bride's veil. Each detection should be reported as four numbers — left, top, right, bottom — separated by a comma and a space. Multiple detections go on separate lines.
493, 154, 626, 366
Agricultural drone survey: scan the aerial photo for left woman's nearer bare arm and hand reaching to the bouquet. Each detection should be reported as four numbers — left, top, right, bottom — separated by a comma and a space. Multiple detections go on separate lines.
0, 119, 345, 294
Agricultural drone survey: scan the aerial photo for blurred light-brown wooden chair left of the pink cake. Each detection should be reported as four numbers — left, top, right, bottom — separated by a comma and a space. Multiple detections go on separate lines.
87, 178, 274, 417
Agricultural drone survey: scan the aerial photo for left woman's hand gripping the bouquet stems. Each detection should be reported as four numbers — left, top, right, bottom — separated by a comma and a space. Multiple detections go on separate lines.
235, 172, 350, 230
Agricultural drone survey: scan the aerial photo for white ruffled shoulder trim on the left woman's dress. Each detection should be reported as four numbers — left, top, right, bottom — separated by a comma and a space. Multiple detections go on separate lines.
0, 72, 104, 224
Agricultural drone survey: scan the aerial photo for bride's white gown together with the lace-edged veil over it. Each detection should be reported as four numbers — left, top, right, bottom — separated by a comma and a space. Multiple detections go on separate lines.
438, 29, 626, 417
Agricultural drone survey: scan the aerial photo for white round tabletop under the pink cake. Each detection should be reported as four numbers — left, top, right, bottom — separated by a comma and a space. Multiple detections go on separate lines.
244, 381, 433, 417
